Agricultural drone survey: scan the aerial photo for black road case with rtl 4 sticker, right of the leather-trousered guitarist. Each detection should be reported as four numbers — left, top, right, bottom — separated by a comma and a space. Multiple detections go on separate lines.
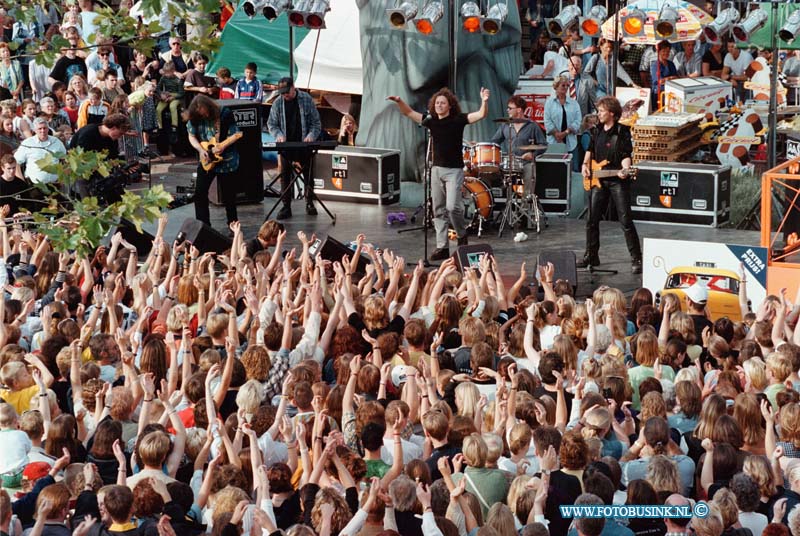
631, 160, 731, 227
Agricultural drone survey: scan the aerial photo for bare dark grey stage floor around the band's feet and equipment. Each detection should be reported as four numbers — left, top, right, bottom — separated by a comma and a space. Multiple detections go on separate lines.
139, 162, 759, 297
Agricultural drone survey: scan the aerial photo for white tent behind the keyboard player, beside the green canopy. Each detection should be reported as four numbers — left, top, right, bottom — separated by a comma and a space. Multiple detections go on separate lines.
294, 0, 363, 95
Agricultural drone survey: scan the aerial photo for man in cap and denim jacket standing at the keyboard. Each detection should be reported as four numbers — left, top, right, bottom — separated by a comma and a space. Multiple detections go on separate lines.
267, 77, 322, 220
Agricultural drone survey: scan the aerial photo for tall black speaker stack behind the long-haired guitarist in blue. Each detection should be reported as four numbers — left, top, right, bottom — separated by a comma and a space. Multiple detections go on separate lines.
208, 99, 264, 205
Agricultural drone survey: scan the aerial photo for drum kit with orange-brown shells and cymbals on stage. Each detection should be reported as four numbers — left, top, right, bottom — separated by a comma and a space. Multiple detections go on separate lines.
462, 118, 547, 236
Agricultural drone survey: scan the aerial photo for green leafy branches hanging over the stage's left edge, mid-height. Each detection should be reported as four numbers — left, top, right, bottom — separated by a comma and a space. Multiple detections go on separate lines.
33, 148, 172, 256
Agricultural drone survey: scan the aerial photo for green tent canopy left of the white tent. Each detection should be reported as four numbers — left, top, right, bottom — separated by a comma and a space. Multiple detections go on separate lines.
206, 2, 309, 84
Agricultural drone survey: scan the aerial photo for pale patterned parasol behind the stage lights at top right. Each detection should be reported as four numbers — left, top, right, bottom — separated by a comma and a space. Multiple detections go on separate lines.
603, 0, 714, 45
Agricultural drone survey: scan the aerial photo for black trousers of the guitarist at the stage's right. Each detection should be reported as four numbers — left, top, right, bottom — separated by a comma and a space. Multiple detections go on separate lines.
586, 179, 642, 259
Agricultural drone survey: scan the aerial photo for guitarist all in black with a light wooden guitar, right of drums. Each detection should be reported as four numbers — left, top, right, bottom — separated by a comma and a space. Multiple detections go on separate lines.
578, 97, 642, 274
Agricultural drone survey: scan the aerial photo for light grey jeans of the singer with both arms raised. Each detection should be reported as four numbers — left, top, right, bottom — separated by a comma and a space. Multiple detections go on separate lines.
431, 166, 467, 248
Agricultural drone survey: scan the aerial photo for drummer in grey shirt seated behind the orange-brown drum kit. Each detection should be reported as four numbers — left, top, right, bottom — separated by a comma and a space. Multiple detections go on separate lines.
491, 95, 547, 194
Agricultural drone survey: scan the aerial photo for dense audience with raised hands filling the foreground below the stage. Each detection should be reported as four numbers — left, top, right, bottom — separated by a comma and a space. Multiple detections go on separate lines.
0, 211, 800, 536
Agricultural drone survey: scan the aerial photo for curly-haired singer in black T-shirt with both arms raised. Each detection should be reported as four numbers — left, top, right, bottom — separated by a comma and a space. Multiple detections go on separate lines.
387, 88, 489, 261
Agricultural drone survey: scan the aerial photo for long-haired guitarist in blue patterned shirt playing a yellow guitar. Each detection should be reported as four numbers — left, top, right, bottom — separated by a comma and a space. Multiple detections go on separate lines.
184, 94, 239, 226
